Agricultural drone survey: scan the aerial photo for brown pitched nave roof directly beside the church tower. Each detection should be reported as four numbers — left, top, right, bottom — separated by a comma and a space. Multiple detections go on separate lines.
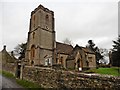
56, 42, 73, 55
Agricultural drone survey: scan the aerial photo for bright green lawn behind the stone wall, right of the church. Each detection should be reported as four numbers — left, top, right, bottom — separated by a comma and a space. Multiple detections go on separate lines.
85, 67, 120, 76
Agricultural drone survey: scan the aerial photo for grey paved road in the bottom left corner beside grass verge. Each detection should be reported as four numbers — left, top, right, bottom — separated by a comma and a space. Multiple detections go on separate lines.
0, 74, 22, 90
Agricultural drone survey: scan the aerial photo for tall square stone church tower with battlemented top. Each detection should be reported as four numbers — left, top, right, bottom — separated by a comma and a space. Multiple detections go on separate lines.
25, 5, 55, 65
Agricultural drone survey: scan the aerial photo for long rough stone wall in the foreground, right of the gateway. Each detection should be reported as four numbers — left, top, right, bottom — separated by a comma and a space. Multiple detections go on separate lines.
22, 66, 120, 89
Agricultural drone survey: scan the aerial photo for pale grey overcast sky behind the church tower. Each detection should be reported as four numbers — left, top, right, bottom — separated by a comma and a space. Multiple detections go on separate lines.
0, 0, 119, 51
